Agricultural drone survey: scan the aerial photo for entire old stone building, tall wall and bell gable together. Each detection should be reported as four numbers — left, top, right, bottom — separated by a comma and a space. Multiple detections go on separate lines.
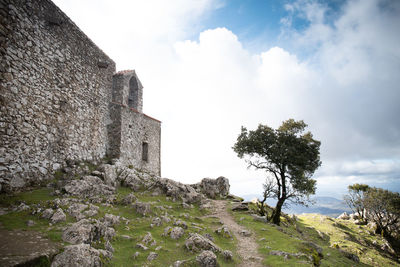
0, 0, 161, 191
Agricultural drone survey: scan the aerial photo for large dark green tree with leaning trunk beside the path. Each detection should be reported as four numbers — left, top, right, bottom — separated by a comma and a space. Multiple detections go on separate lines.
233, 119, 321, 225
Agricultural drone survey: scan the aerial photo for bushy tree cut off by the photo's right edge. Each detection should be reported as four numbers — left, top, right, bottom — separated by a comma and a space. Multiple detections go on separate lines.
364, 187, 400, 238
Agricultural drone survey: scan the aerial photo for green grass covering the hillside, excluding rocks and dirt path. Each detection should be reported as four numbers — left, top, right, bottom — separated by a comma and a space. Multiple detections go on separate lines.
0, 187, 398, 266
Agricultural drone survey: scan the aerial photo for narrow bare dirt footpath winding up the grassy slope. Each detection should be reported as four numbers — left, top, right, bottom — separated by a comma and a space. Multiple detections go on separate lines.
206, 200, 263, 267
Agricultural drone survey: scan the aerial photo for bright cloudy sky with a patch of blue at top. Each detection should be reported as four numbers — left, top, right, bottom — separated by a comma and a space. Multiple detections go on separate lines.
54, 0, 400, 198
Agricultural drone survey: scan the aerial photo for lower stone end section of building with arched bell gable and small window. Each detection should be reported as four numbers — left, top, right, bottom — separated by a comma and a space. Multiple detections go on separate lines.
108, 71, 161, 175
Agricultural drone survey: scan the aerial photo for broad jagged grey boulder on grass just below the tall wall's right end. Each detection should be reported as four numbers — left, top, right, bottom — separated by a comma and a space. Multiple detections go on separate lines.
63, 175, 115, 198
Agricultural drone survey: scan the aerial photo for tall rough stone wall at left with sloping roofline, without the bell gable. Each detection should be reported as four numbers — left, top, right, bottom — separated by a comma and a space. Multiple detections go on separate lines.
0, 0, 115, 193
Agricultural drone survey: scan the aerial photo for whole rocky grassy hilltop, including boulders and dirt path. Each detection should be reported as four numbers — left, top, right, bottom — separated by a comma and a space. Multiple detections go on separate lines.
0, 162, 398, 266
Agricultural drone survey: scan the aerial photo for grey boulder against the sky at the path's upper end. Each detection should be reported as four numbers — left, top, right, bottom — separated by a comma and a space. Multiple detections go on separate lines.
193, 176, 230, 199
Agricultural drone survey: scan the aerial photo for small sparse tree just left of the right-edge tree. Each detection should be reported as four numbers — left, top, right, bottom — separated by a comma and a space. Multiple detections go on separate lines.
344, 184, 369, 220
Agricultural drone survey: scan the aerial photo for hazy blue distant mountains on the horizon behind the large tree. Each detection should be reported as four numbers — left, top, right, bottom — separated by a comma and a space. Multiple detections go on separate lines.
238, 195, 351, 217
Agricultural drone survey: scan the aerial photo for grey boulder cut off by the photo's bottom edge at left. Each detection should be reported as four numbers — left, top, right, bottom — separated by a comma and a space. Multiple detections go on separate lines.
51, 244, 102, 267
